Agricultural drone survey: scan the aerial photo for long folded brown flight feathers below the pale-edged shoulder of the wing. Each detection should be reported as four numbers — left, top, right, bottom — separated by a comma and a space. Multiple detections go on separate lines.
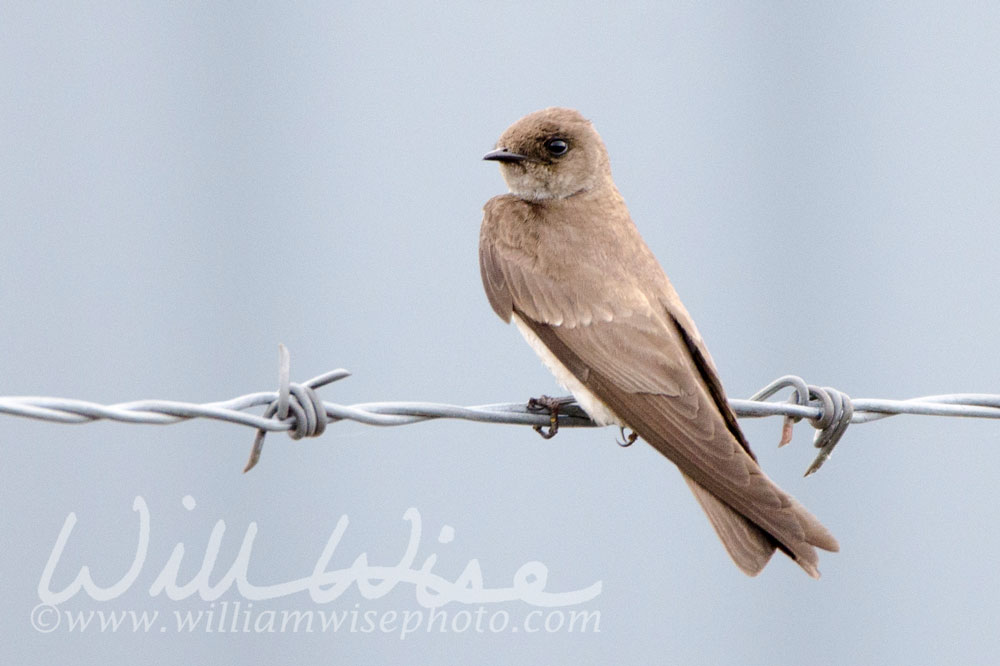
514, 302, 837, 574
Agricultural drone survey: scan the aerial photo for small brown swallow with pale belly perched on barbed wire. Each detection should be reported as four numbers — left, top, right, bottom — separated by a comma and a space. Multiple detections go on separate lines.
479, 108, 838, 578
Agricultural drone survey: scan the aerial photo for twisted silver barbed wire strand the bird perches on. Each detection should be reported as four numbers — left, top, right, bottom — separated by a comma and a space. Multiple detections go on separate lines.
0, 345, 1000, 476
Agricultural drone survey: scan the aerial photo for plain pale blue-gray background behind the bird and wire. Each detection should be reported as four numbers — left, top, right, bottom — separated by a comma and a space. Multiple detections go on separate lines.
0, 2, 1000, 665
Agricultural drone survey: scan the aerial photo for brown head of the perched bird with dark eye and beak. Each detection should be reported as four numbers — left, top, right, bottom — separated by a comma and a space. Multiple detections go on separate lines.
483, 107, 611, 201
